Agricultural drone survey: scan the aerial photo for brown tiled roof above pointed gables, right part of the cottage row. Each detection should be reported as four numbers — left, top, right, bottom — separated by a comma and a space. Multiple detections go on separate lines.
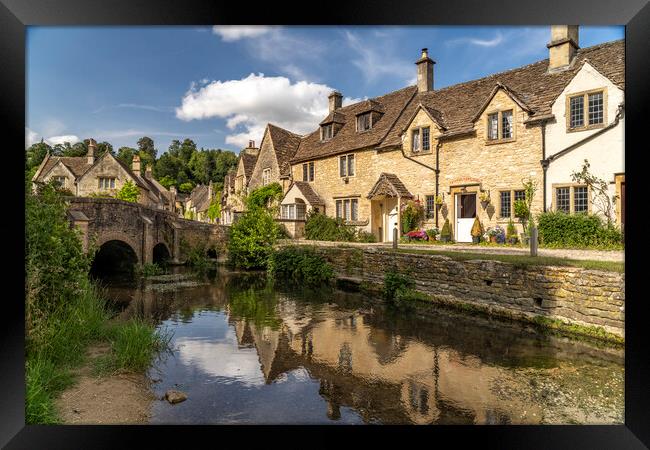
380, 40, 625, 147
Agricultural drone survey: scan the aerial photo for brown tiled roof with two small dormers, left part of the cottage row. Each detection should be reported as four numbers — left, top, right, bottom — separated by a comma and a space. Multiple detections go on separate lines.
291, 86, 417, 163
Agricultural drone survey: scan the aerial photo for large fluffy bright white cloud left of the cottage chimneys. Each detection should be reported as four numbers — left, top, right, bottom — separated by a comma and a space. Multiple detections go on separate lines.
176, 73, 359, 147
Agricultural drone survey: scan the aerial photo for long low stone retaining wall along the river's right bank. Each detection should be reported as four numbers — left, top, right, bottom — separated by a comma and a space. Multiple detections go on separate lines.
308, 247, 625, 336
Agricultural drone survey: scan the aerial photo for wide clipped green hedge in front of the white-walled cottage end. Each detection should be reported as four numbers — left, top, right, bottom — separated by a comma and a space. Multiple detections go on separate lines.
538, 211, 623, 247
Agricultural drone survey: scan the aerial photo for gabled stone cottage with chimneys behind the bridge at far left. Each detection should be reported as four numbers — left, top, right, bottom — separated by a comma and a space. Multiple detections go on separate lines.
32, 139, 176, 211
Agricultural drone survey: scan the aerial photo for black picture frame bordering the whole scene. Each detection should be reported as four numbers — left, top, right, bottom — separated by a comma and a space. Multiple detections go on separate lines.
0, 0, 650, 449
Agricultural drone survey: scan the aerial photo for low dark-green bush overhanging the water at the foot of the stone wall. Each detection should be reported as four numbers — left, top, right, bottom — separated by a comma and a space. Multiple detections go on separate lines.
267, 246, 334, 286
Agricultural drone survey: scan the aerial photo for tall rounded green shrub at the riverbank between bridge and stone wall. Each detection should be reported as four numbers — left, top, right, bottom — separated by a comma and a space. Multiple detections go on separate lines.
228, 208, 281, 269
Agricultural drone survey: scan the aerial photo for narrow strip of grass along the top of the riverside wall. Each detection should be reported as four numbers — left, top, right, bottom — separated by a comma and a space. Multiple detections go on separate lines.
389, 248, 625, 273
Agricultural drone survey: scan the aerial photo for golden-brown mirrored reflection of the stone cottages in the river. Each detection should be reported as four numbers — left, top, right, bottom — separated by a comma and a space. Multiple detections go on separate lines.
230, 301, 541, 424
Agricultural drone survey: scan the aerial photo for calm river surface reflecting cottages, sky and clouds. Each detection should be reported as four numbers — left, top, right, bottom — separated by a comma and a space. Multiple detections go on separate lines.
104, 271, 622, 424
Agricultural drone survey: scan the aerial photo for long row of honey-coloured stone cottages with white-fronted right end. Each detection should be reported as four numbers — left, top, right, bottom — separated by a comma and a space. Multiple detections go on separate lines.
270, 25, 625, 242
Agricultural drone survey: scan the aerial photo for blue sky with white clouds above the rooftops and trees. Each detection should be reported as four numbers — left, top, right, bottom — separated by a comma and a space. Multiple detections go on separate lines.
26, 26, 624, 154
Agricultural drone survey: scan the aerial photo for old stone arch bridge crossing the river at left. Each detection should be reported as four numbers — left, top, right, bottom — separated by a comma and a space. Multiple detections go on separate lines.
66, 197, 228, 264
